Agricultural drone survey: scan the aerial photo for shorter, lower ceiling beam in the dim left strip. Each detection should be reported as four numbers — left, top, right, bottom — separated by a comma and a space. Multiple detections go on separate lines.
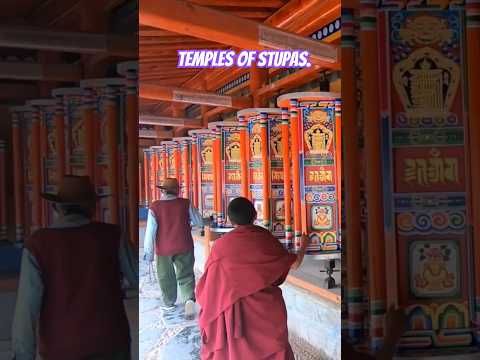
0, 62, 82, 81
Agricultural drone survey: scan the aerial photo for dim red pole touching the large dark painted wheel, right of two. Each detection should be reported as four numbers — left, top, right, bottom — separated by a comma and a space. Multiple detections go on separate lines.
360, 0, 386, 349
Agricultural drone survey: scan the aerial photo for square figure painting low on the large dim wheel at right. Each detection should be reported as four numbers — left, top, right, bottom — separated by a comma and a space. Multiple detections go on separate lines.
410, 241, 460, 297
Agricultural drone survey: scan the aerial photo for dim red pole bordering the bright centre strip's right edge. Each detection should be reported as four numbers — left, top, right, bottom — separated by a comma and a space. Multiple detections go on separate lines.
339, 9, 363, 340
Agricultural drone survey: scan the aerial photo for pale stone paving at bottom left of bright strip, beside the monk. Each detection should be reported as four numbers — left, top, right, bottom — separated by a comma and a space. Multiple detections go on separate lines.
139, 249, 200, 360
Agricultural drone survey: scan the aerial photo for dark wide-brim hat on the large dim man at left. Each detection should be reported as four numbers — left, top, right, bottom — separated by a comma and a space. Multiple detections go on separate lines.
41, 175, 109, 204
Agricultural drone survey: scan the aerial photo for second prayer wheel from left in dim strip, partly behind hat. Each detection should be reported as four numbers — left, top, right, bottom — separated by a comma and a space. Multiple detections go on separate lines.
26, 99, 57, 228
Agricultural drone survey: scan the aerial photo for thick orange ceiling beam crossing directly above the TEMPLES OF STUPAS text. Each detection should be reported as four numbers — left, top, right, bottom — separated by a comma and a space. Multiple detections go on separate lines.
139, 0, 339, 67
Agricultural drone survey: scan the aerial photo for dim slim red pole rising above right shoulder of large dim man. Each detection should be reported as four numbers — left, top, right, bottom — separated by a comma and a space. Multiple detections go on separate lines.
105, 87, 120, 224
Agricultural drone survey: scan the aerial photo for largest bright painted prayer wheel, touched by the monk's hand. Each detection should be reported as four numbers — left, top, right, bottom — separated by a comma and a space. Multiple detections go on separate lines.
277, 92, 341, 253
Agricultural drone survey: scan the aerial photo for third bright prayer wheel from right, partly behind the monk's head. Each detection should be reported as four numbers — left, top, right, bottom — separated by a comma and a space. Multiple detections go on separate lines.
208, 121, 246, 227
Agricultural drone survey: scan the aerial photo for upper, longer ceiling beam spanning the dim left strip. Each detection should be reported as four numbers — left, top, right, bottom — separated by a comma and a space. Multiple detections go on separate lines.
0, 27, 138, 57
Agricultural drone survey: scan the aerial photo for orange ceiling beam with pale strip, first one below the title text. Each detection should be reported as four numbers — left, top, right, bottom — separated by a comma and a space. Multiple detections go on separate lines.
139, 83, 252, 109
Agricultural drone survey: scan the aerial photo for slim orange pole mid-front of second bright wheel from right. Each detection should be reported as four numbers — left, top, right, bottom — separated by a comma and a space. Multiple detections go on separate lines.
260, 113, 271, 229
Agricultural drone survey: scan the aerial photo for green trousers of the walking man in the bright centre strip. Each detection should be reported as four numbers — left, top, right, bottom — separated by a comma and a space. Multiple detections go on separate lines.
157, 250, 195, 305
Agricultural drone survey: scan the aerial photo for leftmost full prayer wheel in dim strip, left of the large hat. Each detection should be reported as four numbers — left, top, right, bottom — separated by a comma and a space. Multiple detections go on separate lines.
10, 106, 33, 245
